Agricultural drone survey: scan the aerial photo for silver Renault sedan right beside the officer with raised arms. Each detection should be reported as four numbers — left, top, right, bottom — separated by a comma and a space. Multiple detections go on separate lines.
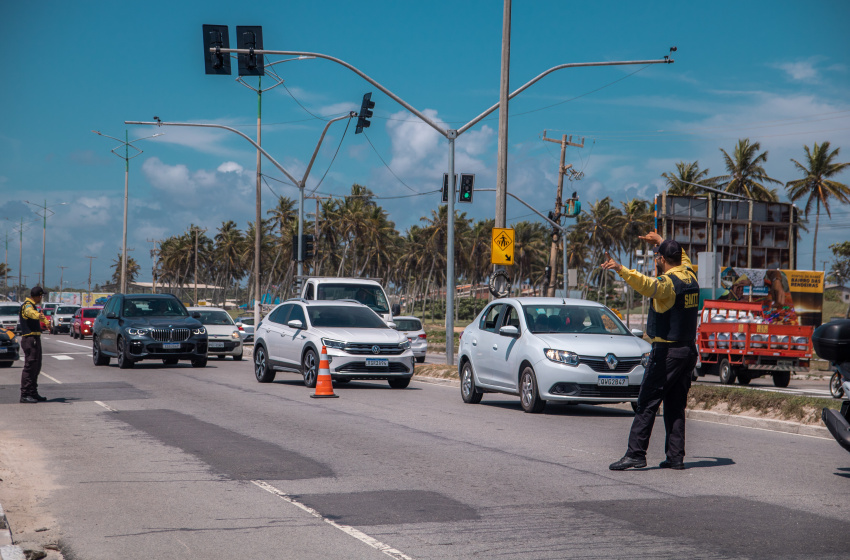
458, 298, 652, 412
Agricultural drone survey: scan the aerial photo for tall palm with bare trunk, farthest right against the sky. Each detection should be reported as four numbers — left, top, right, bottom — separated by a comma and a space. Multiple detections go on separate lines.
785, 142, 850, 270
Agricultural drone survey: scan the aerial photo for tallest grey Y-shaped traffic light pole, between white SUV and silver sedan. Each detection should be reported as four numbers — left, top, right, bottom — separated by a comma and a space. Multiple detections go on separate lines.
207, 47, 675, 365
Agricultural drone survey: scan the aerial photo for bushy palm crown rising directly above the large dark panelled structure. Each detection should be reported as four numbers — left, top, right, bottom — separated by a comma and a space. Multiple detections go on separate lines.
710, 138, 782, 202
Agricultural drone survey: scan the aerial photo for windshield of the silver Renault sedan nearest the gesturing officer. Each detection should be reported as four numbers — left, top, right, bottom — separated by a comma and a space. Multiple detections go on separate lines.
522, 305, 631, 335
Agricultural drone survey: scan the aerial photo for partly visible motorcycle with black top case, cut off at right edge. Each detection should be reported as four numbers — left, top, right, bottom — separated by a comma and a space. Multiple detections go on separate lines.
812, 319, 850, 452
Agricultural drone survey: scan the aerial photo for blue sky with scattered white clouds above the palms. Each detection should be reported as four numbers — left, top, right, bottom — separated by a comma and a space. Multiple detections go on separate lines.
0, 0, 850, 289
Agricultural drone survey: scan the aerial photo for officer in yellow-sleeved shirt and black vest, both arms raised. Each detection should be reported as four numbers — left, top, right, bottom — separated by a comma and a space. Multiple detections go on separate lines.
602, 232, 699, 471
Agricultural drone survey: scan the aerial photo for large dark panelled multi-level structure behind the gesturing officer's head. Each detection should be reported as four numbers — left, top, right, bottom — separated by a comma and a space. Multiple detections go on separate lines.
655, 191, 799, 270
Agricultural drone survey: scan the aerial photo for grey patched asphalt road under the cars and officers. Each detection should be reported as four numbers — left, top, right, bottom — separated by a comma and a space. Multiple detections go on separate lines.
0, 336, 850, 560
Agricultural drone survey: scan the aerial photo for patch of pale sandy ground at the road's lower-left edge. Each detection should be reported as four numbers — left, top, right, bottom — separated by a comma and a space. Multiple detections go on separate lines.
0, 430, 64, 560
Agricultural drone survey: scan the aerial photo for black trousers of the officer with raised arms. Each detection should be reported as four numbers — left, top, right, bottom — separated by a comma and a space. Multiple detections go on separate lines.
626, 344, 697, 461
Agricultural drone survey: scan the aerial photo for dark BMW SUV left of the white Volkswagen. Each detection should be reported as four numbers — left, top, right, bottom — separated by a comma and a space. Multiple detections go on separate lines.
92, 294, 207, 369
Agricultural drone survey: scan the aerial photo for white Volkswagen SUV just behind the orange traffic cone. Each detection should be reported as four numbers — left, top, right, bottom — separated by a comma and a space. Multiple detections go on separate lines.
254, 298, 415, 389
